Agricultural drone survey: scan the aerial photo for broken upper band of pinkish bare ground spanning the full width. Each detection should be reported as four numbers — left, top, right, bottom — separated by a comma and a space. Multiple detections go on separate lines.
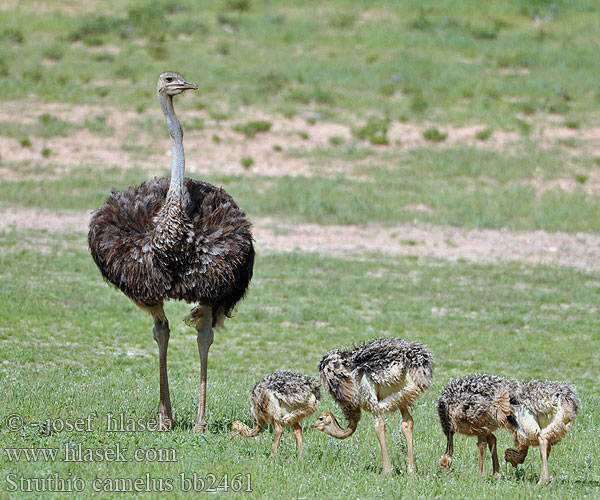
0, 101, 600, 194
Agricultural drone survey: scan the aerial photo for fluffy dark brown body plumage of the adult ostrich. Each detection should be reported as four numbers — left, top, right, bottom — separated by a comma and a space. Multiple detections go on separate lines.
88, 177, 254, 310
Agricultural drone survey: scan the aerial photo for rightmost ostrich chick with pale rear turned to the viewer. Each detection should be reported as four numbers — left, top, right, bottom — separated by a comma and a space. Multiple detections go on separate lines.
504, 380, 581, 483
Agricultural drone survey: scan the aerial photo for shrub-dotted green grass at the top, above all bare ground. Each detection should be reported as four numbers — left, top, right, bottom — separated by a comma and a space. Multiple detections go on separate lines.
0, 0, 600, 128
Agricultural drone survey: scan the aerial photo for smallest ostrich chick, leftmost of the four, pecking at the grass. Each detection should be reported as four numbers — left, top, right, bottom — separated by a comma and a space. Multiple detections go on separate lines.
230, 370, 321, 458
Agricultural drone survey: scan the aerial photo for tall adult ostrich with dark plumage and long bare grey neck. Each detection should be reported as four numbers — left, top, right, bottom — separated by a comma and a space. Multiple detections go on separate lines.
88, 72, 254, 432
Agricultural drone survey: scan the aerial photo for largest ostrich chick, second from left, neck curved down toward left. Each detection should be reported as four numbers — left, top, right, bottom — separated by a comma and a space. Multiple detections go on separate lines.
311, 338, 433, 474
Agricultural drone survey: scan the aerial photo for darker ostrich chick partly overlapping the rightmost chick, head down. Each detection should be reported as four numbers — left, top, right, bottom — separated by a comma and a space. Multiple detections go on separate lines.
438, 375, 518, 477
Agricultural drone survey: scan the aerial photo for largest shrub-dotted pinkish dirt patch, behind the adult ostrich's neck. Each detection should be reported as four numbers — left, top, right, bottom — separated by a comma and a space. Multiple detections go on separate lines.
0, 101, 350, 180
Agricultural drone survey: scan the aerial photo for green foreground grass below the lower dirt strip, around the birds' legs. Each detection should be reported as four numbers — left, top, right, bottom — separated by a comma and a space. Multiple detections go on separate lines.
0, 232, 600, 498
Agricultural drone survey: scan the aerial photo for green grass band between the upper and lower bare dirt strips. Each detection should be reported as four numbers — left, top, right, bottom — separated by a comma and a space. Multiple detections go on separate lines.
0, 144, 600, 232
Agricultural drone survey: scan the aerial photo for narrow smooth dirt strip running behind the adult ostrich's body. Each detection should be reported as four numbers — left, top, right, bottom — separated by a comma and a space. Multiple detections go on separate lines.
0, 207, 600, 272
